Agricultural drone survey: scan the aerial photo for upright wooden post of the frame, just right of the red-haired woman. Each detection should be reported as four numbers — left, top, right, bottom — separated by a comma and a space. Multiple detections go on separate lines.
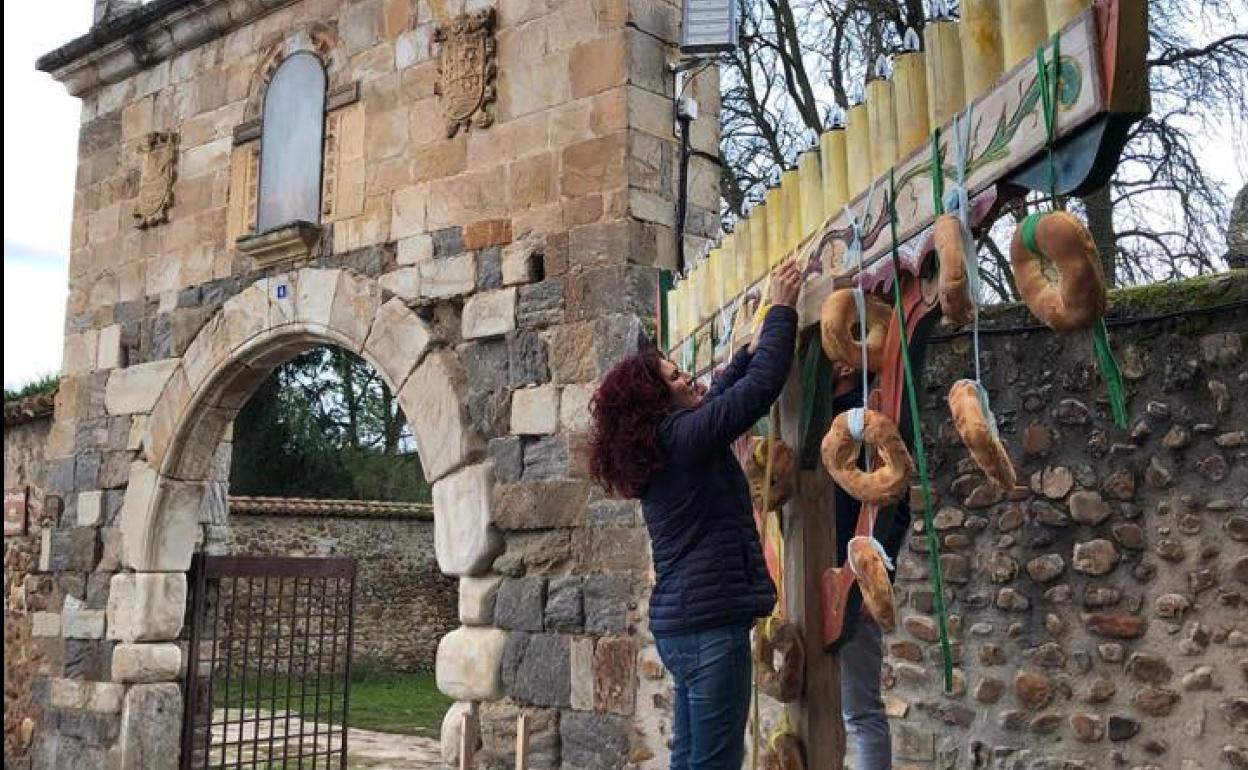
780, 361, 845, 770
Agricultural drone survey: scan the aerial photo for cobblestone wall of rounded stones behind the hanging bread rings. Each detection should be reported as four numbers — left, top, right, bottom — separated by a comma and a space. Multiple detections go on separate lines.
885, 271, 1248, 770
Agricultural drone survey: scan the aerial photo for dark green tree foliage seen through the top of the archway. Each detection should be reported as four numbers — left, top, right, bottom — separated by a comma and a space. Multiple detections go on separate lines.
230, 347, 429, 502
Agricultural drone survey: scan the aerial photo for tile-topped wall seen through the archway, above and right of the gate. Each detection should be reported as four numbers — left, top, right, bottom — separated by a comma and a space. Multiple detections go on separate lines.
222, 500, 458, 671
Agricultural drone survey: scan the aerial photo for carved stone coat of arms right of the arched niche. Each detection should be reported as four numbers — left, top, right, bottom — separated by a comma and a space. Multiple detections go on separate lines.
433, 7, 498, 137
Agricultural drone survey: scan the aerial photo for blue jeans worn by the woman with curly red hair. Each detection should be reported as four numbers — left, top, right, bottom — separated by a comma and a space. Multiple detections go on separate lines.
654, 623, 750, 770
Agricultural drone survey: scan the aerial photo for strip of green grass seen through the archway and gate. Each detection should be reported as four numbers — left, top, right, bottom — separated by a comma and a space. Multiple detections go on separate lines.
212, 670, 453, 738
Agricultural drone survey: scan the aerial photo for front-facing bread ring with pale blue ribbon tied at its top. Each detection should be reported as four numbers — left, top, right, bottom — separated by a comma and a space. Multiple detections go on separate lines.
820, 409, 914, 505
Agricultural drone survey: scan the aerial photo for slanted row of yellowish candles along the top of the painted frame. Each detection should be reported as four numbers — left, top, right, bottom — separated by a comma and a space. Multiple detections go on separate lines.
668, 0, 1091, 341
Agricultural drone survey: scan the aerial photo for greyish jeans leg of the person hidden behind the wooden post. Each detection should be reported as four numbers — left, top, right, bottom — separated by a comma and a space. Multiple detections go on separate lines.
840, 616, 892, 770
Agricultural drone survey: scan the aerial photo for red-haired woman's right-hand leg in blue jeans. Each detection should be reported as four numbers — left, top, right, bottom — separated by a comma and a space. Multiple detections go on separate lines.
685, 624, 751, 770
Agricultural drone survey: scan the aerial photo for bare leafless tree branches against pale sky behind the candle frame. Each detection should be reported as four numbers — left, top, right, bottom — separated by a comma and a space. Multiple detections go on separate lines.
721, 0, 1248, 298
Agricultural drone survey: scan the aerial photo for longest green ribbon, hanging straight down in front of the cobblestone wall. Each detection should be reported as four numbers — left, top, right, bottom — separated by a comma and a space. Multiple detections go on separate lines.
889, 168, 953, 693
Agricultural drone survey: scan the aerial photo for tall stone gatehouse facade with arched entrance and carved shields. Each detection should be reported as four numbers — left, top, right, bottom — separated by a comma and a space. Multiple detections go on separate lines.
27, 0, 718, 770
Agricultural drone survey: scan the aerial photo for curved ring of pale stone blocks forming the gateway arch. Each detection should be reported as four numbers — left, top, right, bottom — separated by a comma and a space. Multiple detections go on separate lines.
122, 268, 484, 575
